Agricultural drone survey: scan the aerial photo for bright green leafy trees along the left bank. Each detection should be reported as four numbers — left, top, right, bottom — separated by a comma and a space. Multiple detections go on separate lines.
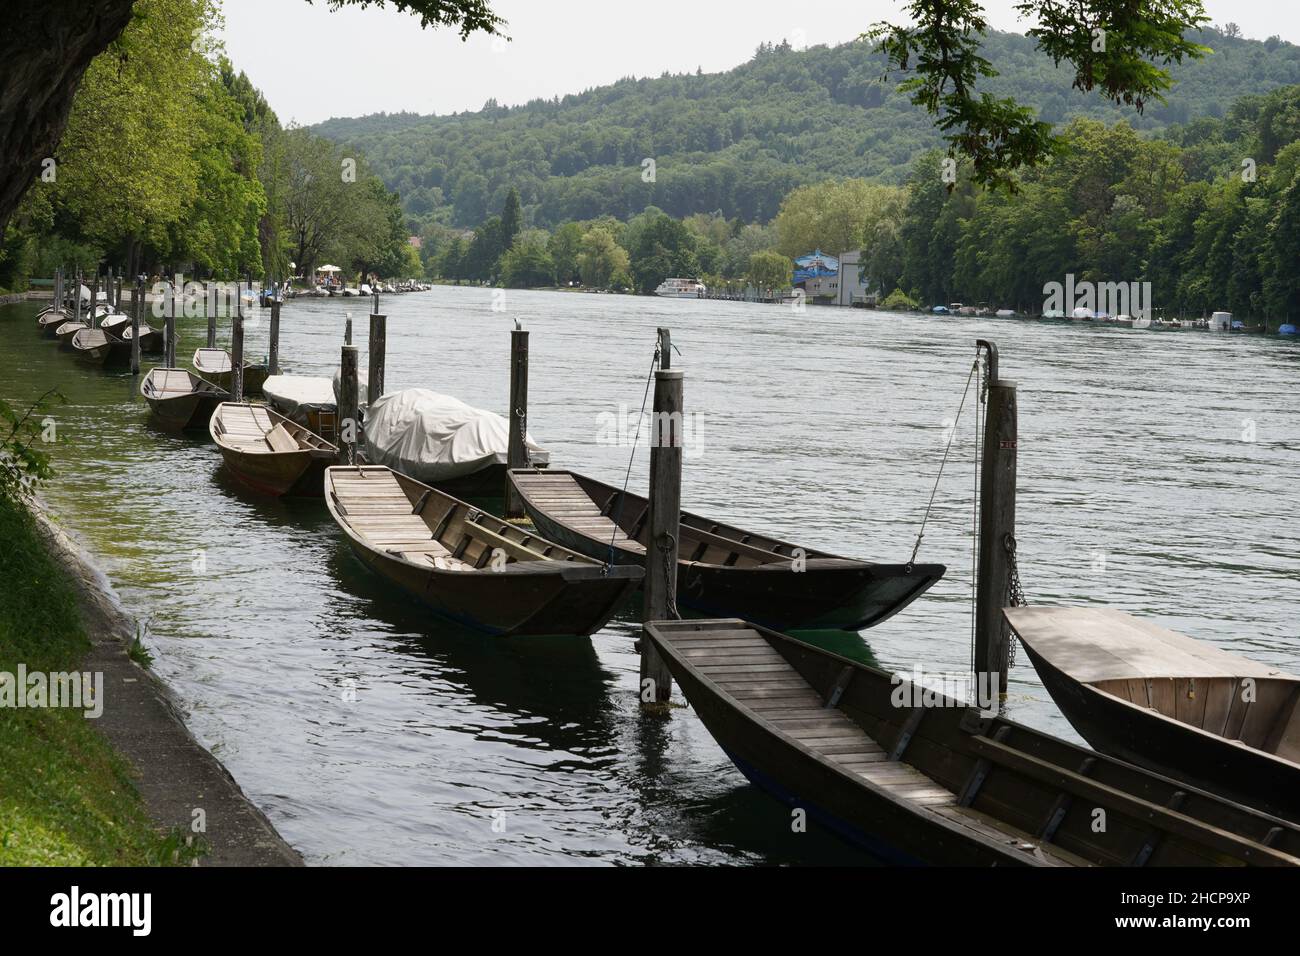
0, 0, 421, 289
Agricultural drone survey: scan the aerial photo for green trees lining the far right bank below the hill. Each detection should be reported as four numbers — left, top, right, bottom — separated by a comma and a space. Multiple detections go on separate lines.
423, 78, 1300, 321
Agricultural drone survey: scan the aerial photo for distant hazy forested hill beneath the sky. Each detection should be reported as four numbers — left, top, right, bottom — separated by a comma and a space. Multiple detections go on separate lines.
316, 30, 1300, 226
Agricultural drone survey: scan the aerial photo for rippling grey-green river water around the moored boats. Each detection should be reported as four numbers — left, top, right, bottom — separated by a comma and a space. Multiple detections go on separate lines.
0, 287, 1300, 865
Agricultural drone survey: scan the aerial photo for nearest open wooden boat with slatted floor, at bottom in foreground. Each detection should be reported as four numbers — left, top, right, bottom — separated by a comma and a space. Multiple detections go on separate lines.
646, 620, 1300, 866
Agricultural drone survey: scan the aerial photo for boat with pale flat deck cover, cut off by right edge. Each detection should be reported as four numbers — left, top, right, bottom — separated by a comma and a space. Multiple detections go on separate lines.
1004, 607, 1300, 822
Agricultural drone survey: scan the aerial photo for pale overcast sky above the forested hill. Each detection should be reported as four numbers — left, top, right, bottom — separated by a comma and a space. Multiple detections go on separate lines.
222, 0, 1300, 124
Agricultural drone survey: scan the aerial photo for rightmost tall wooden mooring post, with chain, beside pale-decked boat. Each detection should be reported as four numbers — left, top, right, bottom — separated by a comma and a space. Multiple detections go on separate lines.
975, 339, 1018, 706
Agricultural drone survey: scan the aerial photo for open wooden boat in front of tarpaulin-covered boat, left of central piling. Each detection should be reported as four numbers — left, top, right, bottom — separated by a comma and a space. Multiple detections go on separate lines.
325, 464, 644, 636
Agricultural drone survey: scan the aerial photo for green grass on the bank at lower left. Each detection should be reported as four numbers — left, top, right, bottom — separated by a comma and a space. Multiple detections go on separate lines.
0, 496, 180, 866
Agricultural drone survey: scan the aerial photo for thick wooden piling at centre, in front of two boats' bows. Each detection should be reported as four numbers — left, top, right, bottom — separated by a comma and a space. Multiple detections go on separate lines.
641, 369, 683, 704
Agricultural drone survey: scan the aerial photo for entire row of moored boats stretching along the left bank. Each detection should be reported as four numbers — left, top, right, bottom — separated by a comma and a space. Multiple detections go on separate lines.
27, 280, 1300, 866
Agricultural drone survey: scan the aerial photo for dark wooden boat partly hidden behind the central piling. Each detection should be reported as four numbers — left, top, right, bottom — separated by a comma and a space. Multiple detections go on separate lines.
511, 468, 945, 631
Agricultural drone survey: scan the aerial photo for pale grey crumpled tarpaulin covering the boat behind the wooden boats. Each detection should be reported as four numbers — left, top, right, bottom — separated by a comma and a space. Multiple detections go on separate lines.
365, 389, 550, 483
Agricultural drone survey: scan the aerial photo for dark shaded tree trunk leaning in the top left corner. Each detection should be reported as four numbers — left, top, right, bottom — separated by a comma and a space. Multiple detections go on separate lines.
0, 0, 135, 239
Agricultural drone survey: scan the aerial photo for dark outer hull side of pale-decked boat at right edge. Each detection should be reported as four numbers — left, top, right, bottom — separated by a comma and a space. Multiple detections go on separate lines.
1022, 641, 1300, 823
